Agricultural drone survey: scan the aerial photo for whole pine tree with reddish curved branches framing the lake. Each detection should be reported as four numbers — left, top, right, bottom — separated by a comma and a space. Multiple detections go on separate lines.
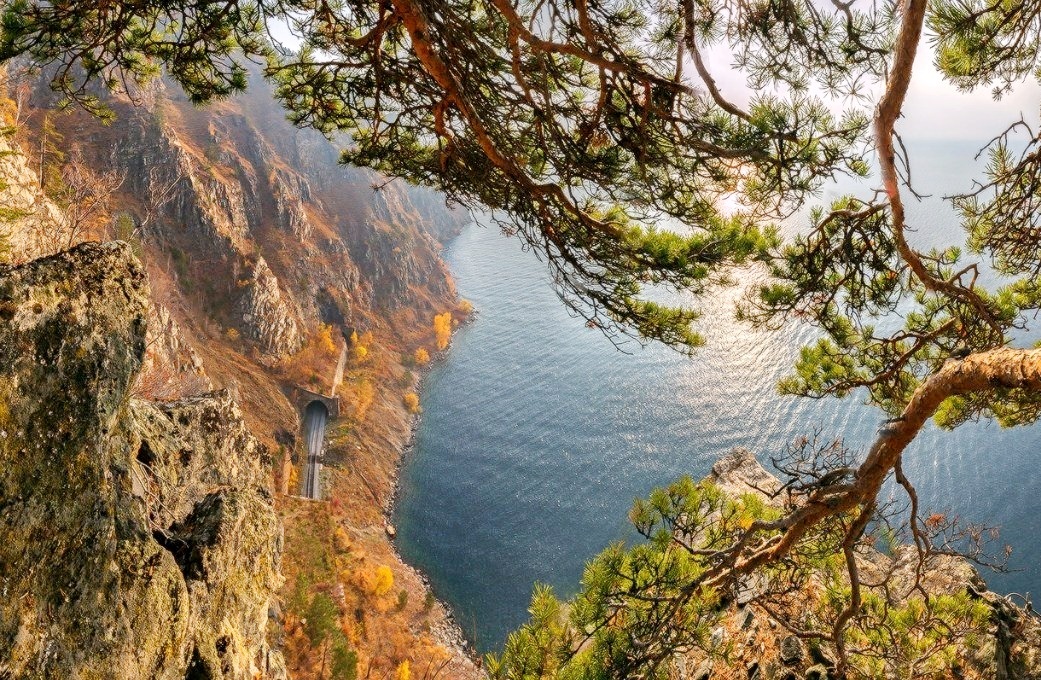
6, 0, 1041, 677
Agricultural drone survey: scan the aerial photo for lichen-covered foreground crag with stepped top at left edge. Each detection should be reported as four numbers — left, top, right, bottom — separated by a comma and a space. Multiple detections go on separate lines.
0, 244, 283, 679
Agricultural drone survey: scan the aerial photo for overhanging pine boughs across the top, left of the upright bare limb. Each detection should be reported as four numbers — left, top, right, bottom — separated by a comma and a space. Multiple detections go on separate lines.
0, 0, 889, 351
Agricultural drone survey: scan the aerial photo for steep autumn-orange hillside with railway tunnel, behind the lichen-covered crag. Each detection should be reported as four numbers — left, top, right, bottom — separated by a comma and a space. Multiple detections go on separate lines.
0, 67, 477, 678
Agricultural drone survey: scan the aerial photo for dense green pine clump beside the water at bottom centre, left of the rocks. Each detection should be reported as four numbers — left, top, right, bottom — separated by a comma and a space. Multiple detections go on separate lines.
487, 478, 777, 679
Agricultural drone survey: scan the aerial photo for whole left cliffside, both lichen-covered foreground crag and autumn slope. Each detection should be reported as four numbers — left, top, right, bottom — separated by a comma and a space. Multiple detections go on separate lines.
0, 70, 477, 678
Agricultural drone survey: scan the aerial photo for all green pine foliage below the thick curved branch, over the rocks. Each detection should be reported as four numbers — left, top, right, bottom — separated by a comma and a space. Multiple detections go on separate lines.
487, 478, 991, 680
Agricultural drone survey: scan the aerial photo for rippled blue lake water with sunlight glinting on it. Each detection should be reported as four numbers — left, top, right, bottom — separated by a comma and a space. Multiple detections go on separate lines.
395, 137, 1041, 651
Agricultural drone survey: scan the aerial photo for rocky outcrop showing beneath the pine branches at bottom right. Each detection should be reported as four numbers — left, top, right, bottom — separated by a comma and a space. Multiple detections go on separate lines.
678, 449, 1041, 680
